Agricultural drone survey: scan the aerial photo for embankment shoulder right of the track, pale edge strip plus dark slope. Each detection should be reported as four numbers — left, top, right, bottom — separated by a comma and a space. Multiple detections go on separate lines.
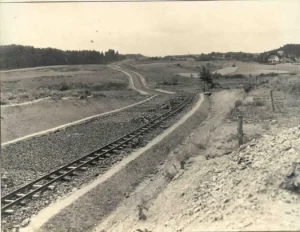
22, 95, 209, 231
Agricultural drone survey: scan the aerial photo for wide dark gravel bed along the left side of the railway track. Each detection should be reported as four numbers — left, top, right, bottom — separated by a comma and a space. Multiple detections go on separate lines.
1, 95, 173, 194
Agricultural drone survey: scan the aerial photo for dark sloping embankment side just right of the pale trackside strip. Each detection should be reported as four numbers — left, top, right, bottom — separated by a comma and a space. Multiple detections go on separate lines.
40, 94, 209, 231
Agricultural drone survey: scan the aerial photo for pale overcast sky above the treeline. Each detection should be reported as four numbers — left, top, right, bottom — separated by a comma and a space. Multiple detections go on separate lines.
0, 1, 300, 56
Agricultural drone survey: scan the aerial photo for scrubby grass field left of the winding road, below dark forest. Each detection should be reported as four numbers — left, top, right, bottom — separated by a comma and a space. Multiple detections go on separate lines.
0, 65, 135, 105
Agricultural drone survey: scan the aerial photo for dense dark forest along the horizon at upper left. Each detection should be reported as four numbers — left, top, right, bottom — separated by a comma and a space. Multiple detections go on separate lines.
0, 45, 125, 69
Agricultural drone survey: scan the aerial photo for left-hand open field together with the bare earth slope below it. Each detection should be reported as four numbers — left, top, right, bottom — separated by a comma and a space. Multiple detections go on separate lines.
1, 65, 148, 143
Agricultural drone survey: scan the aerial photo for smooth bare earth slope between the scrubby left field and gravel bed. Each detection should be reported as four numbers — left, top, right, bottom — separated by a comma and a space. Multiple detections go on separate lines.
1, 91, 145, 143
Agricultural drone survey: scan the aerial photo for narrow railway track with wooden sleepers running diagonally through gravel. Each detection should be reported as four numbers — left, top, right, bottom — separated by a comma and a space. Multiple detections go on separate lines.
1, 95, 193, 215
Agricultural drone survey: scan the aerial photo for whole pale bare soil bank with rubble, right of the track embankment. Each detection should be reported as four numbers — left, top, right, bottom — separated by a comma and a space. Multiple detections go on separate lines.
94, 84, 300, 232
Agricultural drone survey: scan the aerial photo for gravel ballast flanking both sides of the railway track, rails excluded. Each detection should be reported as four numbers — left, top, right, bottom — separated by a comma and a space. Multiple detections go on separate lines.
1, 92, 197, 228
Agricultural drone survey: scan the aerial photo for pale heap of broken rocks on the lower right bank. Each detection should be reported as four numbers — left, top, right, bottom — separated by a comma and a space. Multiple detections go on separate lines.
178, 127, 300, 229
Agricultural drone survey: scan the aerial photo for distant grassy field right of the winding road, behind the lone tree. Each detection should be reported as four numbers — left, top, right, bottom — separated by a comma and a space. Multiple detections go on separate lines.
128, 60, 300, 94
